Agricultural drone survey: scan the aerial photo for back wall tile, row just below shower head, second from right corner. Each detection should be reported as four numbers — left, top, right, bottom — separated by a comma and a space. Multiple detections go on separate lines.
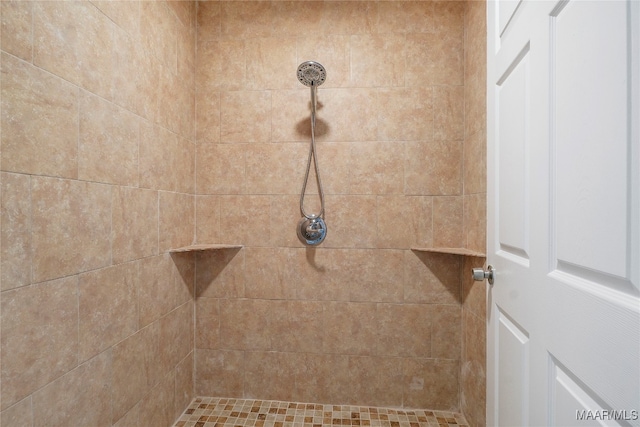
378, 88, 435, 141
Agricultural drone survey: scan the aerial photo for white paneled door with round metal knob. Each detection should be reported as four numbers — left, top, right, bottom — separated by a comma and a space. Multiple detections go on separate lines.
487, 0, 640, 426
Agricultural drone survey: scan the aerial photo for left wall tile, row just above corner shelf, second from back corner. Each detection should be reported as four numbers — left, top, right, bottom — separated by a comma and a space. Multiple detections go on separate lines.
111, 187, 158, 263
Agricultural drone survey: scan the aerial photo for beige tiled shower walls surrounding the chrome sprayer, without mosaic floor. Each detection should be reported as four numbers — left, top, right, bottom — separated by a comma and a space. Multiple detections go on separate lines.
0, 0, 486, 427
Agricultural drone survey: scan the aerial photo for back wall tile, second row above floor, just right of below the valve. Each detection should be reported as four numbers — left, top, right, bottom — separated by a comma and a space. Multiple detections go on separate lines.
323, 302, 378, 356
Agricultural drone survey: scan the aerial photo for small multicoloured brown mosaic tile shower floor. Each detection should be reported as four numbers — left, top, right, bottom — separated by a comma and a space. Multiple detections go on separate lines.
174, 397, 467, 427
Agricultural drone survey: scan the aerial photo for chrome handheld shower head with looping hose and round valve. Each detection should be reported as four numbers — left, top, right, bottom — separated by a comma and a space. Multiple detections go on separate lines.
297, 61, 327, 246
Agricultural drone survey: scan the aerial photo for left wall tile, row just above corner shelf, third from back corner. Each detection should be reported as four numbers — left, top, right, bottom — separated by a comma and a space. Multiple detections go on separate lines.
31, 177, 111, 282
